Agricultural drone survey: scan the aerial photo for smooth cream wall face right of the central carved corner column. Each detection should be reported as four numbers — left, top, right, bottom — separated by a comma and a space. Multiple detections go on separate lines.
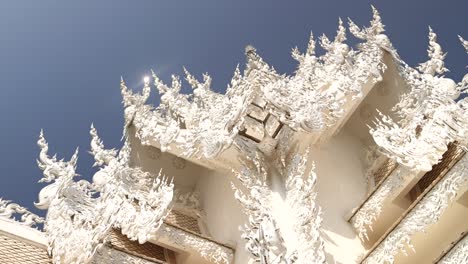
311, 130, 366, 264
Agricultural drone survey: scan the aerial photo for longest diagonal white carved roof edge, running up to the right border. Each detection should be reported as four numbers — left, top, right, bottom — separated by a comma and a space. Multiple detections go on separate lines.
363, 155, 468, 264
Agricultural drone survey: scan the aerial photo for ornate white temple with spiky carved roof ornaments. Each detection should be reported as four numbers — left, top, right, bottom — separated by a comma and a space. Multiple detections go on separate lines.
0, 8, 468, 264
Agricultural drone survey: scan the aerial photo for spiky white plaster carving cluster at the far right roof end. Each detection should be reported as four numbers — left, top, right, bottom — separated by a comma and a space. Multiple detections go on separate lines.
370, 28, 468, 171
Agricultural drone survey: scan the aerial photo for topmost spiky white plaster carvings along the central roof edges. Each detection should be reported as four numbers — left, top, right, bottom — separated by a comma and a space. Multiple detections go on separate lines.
121, 7, 392, 162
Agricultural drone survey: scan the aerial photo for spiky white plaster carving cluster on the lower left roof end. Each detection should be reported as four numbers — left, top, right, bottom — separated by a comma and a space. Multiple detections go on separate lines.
36, 126, 173, 263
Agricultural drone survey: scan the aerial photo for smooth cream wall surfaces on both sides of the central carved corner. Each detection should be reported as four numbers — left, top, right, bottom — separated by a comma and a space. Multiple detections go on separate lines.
127, 121, 367, 264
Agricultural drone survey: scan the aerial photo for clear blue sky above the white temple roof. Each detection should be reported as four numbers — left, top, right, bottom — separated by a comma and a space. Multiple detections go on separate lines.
0, 0, 468, 217
